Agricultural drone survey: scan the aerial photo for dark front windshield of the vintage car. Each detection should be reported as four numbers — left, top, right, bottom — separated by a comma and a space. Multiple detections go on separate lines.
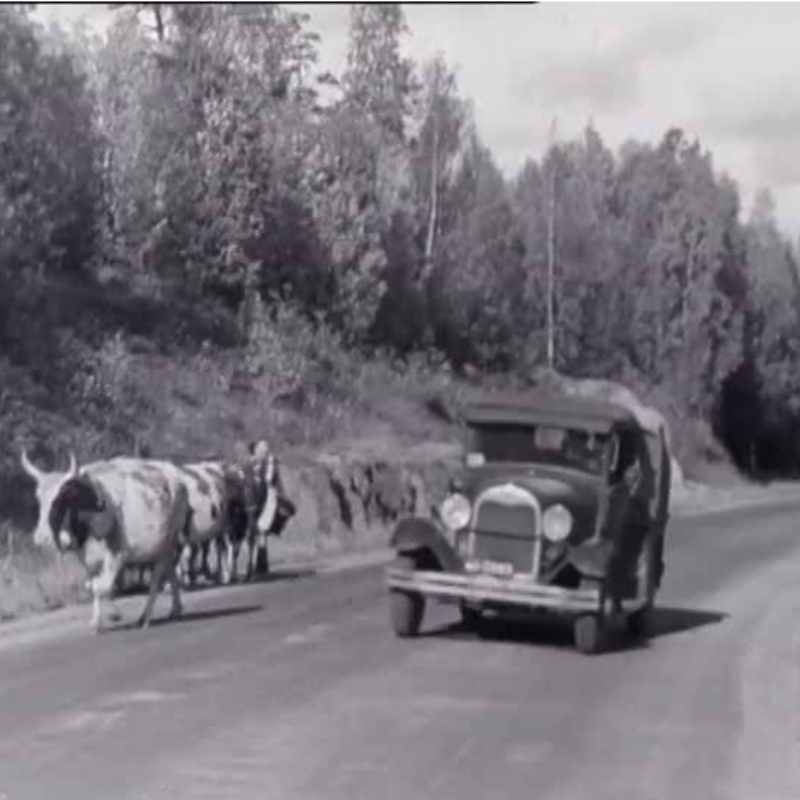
470, 424, 610, 475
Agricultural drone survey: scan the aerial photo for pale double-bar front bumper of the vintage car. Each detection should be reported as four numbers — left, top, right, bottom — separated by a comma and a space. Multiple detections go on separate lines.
386, 567, 602, 612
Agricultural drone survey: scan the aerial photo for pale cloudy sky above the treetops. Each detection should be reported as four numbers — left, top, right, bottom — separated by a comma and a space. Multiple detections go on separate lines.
34, 2, 800, 240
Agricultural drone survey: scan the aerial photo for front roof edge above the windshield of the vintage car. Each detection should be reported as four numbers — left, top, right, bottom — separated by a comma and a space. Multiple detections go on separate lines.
463, 390, 640, 432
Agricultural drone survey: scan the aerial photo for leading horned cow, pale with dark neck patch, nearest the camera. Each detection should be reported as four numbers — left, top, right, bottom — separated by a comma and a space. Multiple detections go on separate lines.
21, 449, 190, 632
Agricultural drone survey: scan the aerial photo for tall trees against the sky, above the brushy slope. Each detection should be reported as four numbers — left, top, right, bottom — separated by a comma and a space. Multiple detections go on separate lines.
0, 3, 800, 470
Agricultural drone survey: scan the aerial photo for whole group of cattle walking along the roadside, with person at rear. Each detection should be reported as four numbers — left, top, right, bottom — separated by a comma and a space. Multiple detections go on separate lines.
21, 441, 296, 631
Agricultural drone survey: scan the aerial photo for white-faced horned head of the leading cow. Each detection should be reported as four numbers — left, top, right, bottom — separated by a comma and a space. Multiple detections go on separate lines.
21, 450, 105, 549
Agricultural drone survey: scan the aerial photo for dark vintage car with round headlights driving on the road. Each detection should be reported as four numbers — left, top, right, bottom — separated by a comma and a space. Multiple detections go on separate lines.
387, 393, 671, 654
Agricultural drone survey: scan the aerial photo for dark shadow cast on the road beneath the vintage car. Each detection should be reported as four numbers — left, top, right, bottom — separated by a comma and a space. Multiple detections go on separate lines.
420, 606, 729, 652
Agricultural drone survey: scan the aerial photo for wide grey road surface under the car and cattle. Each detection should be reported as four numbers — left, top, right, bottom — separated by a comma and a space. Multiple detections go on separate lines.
0, 503, 800, 800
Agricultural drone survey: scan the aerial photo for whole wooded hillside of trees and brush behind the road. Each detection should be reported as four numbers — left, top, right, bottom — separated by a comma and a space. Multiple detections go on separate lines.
0, 3, 800, 532
